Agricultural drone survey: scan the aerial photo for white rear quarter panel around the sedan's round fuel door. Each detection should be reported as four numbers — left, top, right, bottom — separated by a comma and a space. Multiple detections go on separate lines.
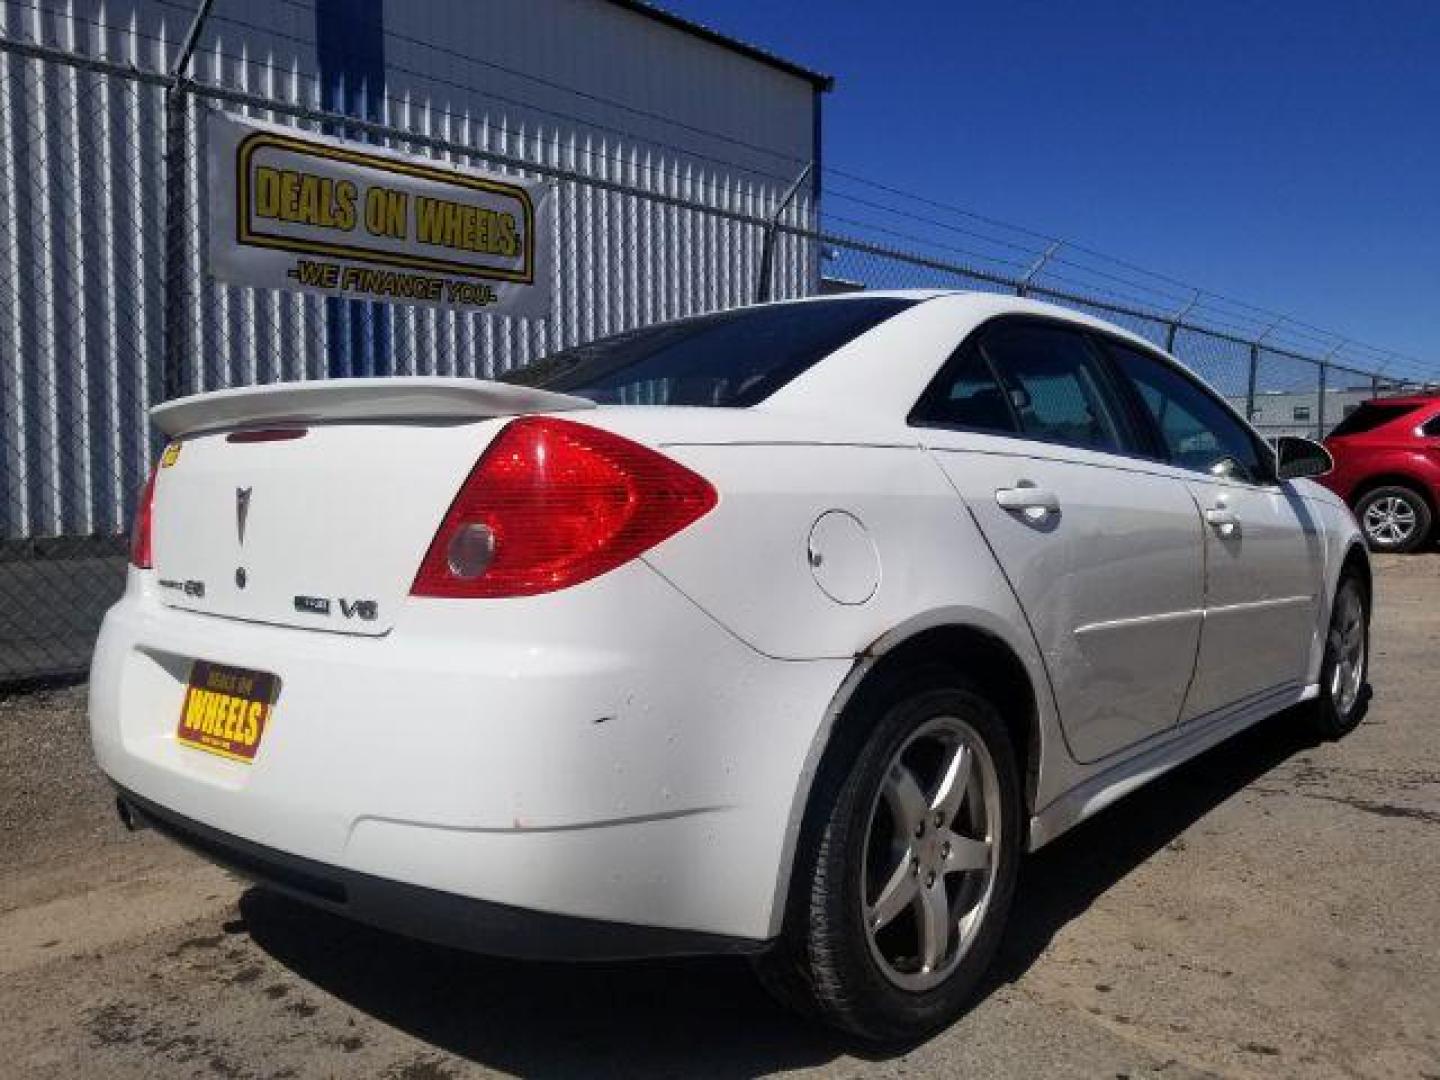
645, 444, 1074, 805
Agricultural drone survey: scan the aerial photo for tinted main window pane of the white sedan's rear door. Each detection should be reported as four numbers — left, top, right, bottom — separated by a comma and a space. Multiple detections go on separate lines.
981, 323, 1129, 451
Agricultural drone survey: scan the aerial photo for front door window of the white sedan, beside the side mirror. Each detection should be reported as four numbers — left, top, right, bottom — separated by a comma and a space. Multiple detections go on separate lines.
1106, 343, 1272, 484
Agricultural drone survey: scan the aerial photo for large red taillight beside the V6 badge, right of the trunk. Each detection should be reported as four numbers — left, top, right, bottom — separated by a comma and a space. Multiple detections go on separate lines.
410, 416, 717, 596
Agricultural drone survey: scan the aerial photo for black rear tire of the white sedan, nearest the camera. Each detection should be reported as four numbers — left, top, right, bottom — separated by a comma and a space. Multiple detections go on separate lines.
756, 672, 1022, 1043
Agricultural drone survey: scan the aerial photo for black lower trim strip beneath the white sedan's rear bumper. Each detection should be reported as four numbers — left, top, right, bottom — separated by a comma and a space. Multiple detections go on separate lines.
120, 788, 766, 960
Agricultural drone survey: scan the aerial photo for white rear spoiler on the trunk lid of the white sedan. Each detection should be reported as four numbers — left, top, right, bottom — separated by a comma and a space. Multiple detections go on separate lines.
150, 376, 595, 438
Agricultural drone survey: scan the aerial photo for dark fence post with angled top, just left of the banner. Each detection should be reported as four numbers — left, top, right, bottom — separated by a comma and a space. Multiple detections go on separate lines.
160, 0, 215, 402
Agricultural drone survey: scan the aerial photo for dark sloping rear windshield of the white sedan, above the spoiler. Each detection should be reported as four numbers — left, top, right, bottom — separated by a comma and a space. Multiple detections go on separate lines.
501, 297, 917, 409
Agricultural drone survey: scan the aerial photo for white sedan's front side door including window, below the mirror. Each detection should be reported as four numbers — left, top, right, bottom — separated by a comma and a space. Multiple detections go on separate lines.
1106, 340, 1325, 720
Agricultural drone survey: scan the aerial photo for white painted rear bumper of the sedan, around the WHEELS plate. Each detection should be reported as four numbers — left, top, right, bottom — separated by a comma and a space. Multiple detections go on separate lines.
91, 563, 848, 955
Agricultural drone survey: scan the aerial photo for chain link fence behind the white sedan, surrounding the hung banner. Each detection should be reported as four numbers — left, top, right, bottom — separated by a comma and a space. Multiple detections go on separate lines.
0, 27, 1434, 684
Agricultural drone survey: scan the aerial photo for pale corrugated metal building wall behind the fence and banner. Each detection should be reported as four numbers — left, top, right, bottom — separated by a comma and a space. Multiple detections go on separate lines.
0, 0, 818, 539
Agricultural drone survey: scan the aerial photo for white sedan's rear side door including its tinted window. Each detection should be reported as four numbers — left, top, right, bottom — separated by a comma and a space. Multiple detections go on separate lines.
910, 318, 1204, 762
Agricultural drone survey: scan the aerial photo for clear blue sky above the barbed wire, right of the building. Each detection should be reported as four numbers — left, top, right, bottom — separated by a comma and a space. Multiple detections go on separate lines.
665, 0, 1440, 370
